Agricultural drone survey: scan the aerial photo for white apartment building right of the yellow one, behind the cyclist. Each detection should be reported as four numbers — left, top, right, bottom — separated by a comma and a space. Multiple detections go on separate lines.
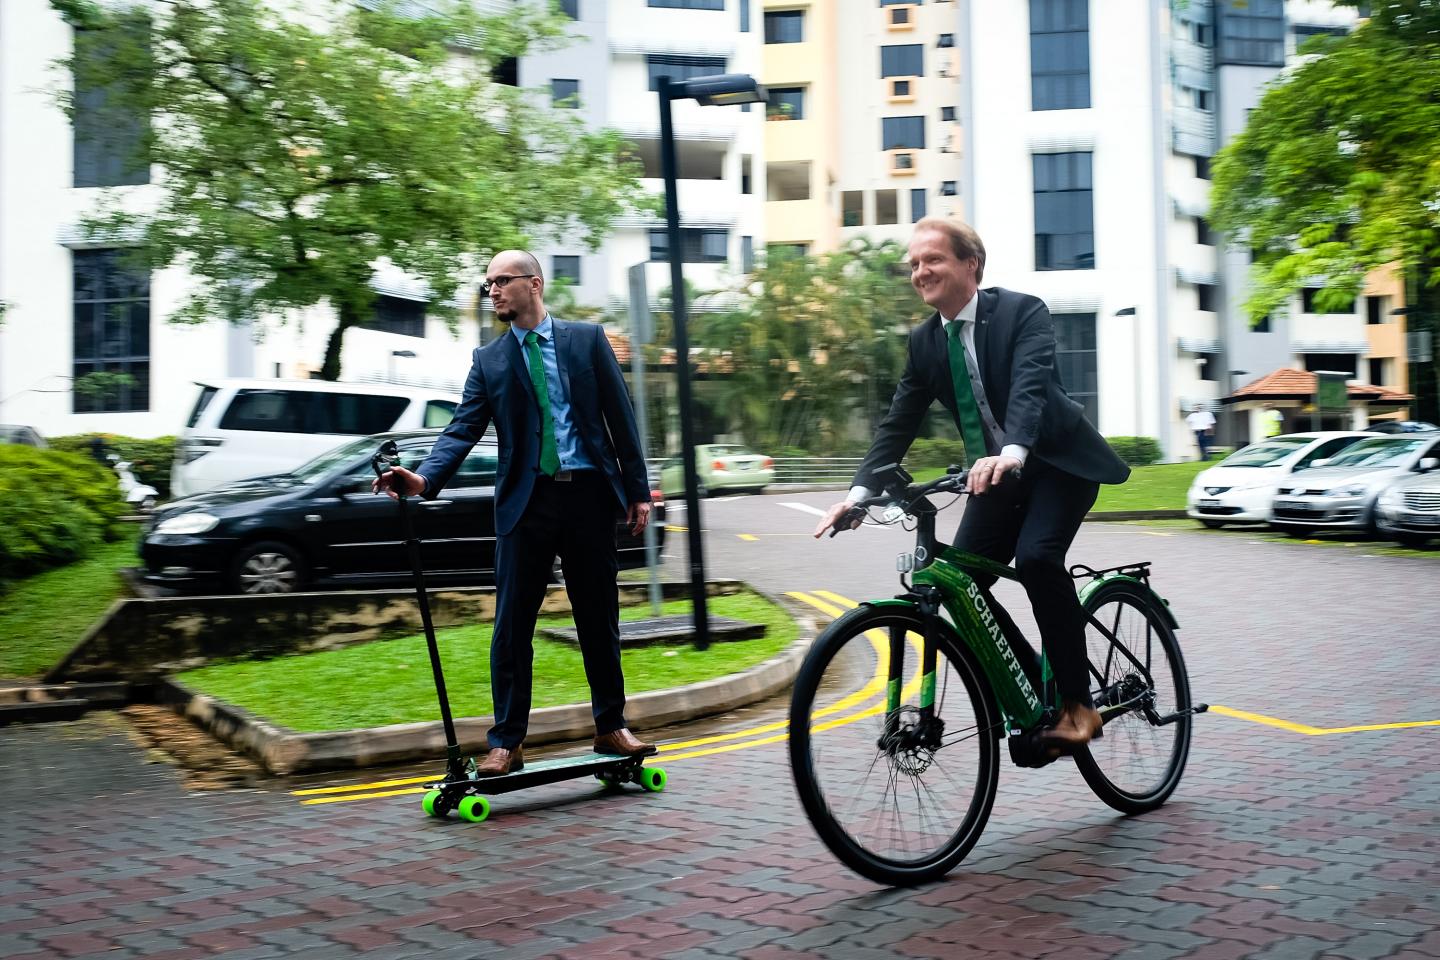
955, 0, 1403, 459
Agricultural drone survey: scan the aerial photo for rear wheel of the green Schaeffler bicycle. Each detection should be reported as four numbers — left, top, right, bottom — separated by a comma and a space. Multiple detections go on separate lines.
1076, 581, 1192, 813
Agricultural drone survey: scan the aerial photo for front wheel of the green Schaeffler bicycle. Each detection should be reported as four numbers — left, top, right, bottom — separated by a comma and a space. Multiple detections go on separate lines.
789, 606, 1001, 885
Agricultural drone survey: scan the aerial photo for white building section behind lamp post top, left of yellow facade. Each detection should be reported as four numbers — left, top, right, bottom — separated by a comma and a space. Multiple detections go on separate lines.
518, 0, 765, 322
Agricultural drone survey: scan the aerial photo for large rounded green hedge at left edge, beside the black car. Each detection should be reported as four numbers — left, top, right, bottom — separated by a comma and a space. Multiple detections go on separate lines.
0, 443, 128, 581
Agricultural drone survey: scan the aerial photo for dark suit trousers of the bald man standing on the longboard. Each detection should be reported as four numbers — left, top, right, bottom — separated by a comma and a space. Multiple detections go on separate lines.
487, 471, 625, 750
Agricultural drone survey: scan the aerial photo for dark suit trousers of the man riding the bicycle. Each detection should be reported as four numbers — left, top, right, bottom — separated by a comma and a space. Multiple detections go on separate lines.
955, 456, 1100, 705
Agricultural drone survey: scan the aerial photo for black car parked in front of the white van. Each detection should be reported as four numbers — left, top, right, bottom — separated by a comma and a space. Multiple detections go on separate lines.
140, 430, 665, 593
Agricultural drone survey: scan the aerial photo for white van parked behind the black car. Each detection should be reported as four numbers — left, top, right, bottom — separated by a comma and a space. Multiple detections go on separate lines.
170, 380, 459, 498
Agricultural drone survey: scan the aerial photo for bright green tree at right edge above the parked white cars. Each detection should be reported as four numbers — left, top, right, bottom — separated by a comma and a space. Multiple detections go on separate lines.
1211, 0, 1440, 420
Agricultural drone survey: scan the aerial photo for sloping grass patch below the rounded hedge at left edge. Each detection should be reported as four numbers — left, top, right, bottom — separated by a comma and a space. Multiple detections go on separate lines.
0, 524, 140, 679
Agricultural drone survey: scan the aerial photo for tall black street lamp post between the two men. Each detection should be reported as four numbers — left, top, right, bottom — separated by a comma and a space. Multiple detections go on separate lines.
655, 73, 765, 651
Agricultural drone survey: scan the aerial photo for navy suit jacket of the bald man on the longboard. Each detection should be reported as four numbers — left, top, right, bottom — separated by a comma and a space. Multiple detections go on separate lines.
415, 317, 649, 535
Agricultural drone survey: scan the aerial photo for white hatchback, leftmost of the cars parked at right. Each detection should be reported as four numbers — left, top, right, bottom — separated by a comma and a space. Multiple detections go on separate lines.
1185, 430, 1375, 528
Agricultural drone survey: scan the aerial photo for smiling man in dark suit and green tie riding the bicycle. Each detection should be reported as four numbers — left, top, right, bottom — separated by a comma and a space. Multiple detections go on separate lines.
815, 217, 1130, 748
